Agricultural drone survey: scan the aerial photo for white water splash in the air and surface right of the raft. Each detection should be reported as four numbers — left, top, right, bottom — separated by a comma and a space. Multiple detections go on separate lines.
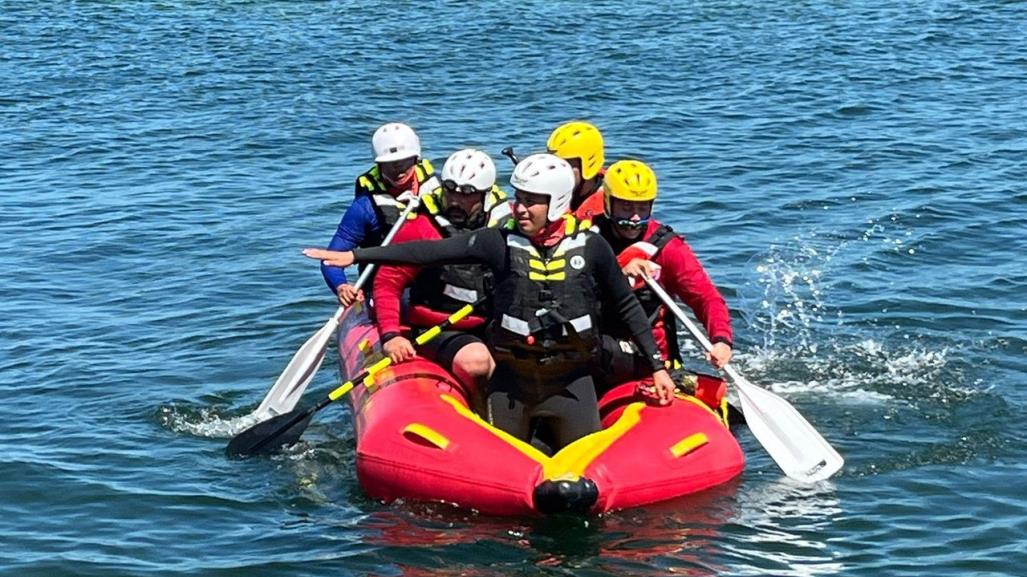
736, 222, 982, 403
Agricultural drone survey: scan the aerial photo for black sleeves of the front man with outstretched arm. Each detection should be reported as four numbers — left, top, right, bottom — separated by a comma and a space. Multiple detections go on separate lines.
353, 228, 663, 372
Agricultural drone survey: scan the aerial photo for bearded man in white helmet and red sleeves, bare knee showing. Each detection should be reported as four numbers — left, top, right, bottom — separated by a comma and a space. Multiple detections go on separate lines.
374, 149, 510, 398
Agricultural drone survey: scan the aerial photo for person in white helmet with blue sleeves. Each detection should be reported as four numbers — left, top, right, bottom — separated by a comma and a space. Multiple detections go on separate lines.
321, 122, 433, 306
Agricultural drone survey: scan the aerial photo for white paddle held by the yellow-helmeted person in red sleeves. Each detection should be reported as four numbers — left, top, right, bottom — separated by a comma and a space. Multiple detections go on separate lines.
645, 276, 845, 483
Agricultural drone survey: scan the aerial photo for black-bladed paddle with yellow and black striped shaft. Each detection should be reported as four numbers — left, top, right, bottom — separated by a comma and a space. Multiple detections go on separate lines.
225, 297, 486, 458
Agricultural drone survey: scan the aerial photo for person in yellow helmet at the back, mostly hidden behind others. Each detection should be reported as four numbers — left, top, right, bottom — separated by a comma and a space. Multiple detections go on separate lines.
545, 120, 606, 222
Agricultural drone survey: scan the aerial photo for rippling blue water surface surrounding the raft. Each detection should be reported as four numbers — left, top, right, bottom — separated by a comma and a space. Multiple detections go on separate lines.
0, 0, 1027, 577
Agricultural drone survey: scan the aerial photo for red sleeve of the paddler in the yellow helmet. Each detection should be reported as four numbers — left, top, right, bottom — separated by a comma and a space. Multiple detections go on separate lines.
656, 237, 733, 344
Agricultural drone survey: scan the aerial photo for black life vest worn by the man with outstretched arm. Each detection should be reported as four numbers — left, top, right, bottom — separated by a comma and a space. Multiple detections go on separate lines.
489, 216, 602, 377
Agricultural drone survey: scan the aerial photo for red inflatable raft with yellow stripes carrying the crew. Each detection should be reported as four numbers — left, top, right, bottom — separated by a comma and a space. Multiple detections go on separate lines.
339, 306, 745, 515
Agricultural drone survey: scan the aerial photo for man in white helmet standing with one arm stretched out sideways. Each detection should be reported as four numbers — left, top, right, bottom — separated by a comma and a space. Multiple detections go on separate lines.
304, 154, 674, 450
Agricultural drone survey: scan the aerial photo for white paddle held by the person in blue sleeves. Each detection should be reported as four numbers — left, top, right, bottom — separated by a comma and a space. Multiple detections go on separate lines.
248, 190, 423, 421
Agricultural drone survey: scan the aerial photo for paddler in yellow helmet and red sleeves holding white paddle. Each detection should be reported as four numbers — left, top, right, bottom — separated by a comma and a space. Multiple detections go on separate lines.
596, 160, 732, 385
